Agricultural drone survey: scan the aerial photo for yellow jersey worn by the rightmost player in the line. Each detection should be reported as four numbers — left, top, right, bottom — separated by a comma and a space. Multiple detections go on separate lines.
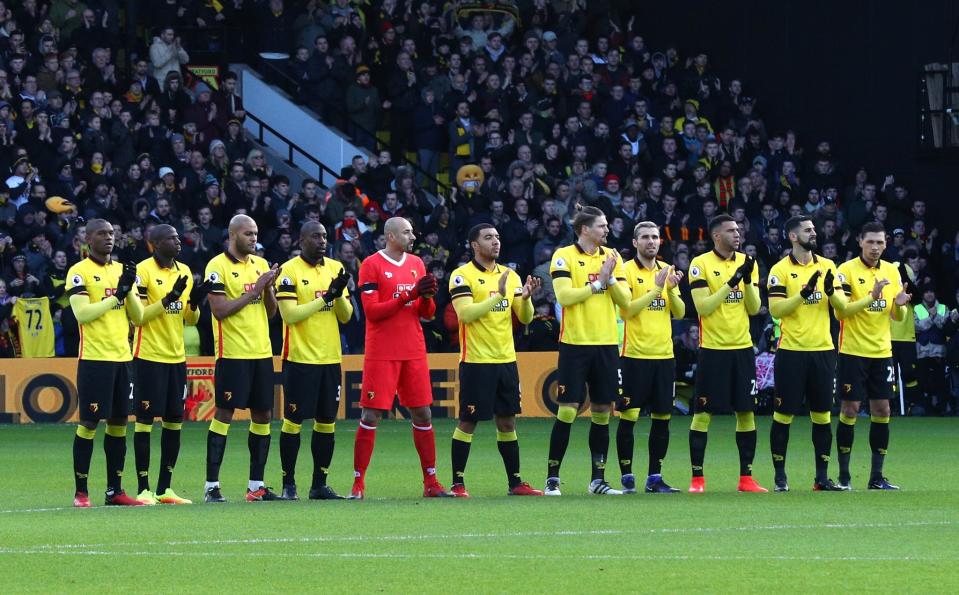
839, 258, 902, 357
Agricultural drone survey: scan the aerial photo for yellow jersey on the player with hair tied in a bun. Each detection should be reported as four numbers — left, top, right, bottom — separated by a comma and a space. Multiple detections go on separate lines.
549, 243, 626, 346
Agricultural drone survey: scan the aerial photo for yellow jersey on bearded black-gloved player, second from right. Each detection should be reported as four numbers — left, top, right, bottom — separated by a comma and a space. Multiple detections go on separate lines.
766, 254, 842, 351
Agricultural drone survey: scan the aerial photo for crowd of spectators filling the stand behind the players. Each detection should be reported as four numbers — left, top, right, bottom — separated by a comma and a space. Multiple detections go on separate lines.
0, 0, 959, 413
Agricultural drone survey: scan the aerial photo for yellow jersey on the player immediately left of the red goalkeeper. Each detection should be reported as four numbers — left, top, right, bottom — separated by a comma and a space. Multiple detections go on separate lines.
276, 256, 349, 364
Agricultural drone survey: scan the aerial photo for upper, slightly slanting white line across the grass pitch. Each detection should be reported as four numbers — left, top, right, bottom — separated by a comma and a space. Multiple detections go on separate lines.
9, 520, 959, 559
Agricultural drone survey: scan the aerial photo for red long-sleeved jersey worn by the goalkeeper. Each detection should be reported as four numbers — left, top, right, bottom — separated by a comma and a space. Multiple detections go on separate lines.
358, 250, 436, 360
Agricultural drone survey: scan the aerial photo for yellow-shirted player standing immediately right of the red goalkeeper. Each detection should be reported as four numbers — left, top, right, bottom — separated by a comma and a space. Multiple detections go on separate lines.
449, 223, 543, 498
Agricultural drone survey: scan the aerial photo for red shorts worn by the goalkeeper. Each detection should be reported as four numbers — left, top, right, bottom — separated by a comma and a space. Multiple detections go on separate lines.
360, 358, 433, 411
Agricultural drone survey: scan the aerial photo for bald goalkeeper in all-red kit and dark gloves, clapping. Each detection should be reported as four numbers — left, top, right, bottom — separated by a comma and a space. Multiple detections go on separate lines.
350, 217, 451, 499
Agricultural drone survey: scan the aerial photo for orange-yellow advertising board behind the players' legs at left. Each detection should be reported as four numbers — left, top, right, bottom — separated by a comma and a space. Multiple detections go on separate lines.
0, 352, 588, 423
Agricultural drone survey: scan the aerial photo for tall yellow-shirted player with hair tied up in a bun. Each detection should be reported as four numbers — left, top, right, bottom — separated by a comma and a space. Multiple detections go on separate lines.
545, 207, 629, 496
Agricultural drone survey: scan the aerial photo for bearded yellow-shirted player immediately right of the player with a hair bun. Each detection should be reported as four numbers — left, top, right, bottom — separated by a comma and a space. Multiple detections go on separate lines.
616, 221, 686, 494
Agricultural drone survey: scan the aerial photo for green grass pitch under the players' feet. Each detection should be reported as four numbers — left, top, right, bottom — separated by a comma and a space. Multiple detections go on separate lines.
0, 418, 959, 593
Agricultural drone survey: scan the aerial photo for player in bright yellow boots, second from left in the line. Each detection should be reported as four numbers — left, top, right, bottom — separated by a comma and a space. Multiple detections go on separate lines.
133, 225, 205, 504
